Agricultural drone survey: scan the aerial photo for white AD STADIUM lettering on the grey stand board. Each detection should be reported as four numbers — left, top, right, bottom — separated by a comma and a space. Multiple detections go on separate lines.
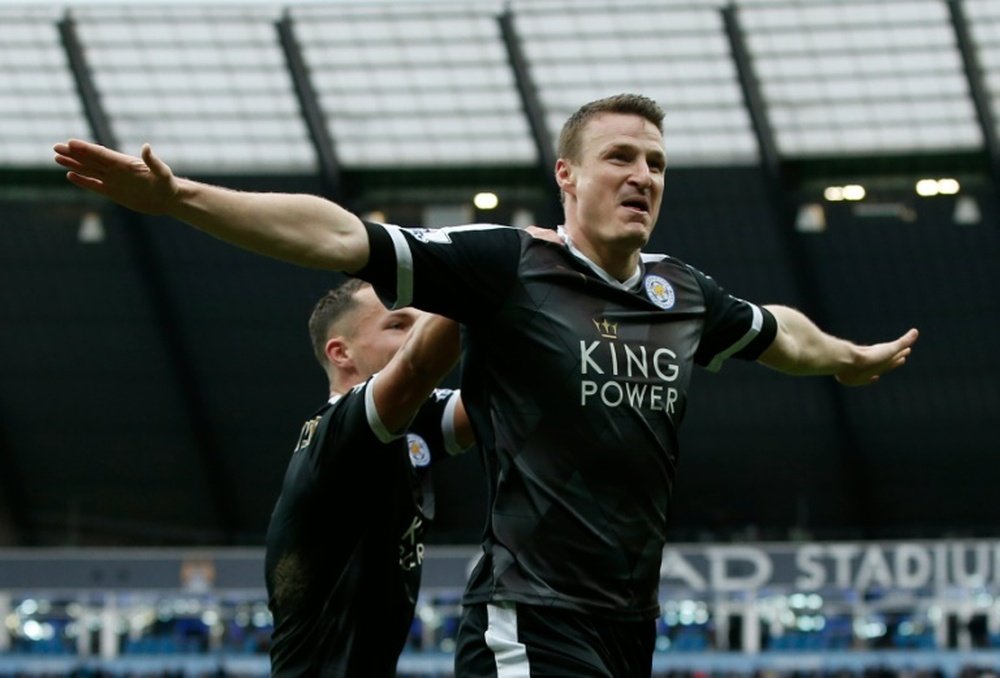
660, 541, 1000, 593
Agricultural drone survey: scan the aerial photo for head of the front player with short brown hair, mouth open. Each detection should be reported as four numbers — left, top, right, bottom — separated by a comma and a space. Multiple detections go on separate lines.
556, 94, 666, 274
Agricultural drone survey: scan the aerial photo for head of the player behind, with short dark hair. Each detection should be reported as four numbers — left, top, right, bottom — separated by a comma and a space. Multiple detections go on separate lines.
309, 278, 420, 391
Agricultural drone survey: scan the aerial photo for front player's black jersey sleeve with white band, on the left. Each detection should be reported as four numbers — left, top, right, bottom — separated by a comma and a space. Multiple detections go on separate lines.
355, 222, 531, 322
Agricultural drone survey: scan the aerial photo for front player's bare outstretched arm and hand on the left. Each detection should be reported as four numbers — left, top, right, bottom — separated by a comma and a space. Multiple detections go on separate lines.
54, 139, 368, 273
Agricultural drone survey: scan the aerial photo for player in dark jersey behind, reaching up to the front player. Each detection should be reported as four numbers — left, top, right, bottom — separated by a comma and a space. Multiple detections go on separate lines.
265, 279, 473, 678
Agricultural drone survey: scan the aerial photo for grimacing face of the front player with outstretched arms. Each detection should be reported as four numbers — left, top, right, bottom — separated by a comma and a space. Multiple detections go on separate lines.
564, 113, 667, 254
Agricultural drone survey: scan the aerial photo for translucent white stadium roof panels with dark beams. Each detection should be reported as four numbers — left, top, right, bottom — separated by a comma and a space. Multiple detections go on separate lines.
0, 0, 1000, 174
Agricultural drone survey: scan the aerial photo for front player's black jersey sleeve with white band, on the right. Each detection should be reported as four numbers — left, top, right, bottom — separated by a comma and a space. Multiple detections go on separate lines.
689, 266, 778, 372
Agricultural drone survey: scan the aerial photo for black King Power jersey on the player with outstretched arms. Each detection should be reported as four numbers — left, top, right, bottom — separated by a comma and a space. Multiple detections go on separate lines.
358, 224, 776, 620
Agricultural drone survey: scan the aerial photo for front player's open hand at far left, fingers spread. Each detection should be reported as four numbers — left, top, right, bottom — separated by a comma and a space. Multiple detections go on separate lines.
53, 139, 178, 214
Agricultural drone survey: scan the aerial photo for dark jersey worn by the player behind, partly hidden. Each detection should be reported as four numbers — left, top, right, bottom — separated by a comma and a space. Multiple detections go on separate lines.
265, 376, 468, 678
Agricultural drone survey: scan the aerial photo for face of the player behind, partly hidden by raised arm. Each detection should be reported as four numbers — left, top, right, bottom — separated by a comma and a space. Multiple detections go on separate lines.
347, 286, 422, 379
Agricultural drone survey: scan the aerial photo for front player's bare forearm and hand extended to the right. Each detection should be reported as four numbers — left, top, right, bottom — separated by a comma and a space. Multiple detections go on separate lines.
758, 305, 919, 386
